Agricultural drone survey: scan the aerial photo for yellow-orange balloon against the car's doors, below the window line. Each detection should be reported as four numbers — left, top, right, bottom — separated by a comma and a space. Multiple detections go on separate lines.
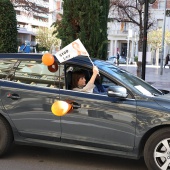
51, 101, 72, 116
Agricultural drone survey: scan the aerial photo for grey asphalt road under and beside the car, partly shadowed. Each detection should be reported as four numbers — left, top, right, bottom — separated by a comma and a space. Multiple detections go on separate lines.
0, 145, 147, 170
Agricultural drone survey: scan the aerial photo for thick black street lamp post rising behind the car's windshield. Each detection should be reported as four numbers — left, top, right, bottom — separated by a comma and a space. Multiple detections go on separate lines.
138, 0, 156, 80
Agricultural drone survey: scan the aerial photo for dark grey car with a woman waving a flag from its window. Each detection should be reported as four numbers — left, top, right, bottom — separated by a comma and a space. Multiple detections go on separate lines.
0, 53, 170, 170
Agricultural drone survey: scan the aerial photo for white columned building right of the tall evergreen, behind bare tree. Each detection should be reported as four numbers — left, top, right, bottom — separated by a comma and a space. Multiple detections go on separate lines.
108, 0, 170, 63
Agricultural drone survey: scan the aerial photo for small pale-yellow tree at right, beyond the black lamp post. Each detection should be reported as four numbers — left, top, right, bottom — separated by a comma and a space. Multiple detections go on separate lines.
148, 29, 170, 66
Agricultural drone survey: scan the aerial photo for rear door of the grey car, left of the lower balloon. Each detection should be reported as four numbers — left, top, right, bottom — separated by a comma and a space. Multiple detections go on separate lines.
1, 61, 61, 141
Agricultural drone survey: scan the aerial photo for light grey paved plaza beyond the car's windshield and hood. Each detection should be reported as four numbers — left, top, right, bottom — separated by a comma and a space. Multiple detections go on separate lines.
119, 64, 170, 91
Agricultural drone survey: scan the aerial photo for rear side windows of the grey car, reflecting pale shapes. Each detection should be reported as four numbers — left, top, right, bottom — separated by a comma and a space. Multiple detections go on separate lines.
0, 60, 64, 88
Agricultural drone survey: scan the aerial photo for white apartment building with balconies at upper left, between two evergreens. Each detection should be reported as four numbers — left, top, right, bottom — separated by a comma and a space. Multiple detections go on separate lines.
11, 0, 62, 46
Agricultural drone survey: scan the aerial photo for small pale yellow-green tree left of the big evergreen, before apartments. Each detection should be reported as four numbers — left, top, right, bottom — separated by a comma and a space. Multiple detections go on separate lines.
36, 27, 61, 51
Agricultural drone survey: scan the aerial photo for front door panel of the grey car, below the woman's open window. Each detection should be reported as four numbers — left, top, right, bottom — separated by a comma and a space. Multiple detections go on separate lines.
60, 85, 136, 151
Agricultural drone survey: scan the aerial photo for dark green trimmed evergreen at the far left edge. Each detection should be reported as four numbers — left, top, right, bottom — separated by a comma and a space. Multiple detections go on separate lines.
0, 0, 17, 53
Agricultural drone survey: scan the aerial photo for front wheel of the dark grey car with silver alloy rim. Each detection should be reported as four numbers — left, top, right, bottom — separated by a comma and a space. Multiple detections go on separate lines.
144, 128, 170, 170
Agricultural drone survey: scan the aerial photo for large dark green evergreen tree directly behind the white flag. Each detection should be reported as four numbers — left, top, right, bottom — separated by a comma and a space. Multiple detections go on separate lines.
54, 0, 109, 59
